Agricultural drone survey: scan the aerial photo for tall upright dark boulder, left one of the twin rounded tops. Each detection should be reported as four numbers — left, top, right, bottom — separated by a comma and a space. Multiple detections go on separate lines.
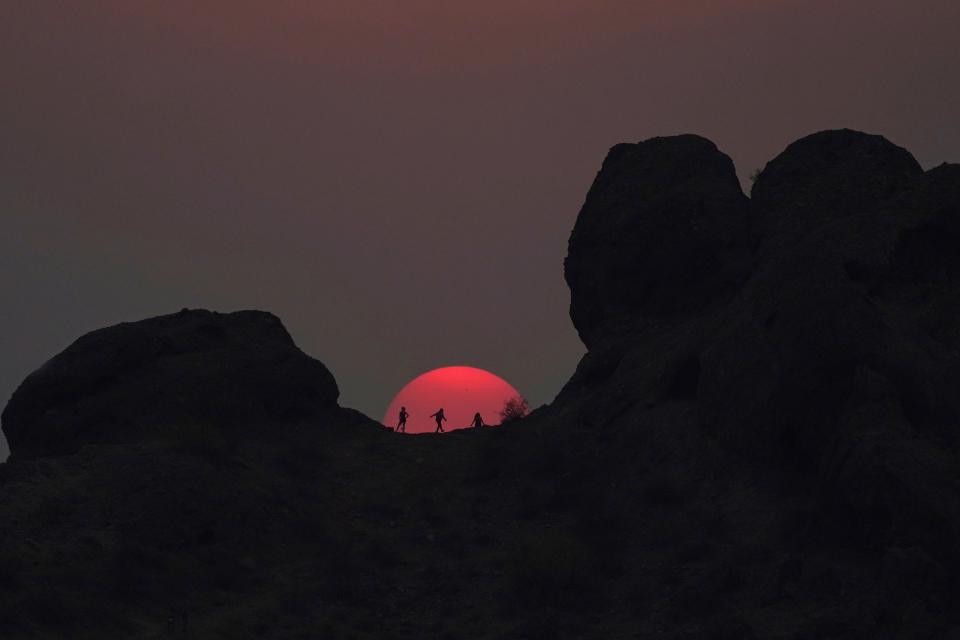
564, 135, 750, 347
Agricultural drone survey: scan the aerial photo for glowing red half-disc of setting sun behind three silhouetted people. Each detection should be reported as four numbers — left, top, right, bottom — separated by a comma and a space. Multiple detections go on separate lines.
383, 367, 520, 433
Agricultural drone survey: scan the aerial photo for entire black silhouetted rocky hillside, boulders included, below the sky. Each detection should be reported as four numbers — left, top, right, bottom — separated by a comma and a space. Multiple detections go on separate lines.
0, 131, 960, 640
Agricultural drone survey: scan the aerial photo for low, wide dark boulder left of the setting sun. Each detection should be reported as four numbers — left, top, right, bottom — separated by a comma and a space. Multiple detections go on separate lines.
2, 310, 339, 457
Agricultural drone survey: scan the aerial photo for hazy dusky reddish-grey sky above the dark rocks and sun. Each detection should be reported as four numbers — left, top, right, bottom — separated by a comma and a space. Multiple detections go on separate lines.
0, 0, 960, 456
